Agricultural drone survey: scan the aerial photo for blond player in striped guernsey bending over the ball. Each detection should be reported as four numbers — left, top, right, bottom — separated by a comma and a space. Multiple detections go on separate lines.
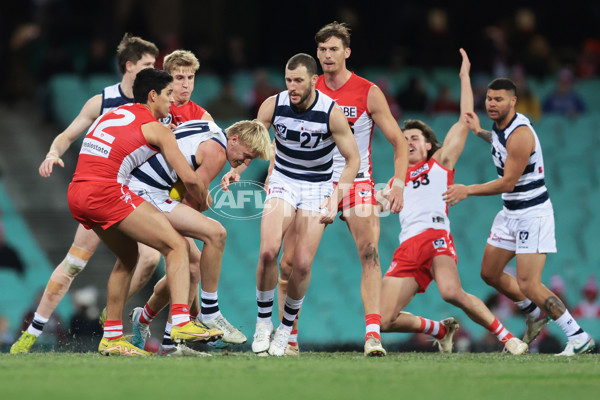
128, 120, 271, 355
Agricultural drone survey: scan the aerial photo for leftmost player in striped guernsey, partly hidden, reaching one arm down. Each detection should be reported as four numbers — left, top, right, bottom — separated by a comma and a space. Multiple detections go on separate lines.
11, 33, 160, 353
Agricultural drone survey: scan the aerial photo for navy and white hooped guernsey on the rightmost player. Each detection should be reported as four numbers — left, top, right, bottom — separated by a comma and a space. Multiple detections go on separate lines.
492, 113, 553, 217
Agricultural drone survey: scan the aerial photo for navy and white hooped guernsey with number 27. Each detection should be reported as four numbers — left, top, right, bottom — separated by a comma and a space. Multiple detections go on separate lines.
271, 90, 336, 182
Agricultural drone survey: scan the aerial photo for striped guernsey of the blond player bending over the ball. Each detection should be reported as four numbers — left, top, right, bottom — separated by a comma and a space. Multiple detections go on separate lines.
128, 120, 227, 190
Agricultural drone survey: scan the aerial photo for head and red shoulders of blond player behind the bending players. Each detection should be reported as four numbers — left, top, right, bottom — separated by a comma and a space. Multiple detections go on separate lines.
160, 50, 213, 127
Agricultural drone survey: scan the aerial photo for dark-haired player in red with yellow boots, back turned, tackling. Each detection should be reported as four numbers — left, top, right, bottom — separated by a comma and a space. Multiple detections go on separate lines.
68, 68, 209, 356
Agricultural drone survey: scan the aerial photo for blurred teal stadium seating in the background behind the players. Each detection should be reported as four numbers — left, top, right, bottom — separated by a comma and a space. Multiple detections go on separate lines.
10, 67, 600, 350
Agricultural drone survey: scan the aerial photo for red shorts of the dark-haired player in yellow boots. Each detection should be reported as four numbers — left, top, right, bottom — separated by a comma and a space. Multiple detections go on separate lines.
67, 181, 145, 230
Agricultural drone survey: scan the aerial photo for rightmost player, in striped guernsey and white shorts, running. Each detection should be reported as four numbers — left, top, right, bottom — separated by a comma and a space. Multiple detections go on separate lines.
445, 78, 595, 356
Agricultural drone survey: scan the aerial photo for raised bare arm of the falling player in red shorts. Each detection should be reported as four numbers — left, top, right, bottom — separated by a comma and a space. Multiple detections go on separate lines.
433, 49, 473, 170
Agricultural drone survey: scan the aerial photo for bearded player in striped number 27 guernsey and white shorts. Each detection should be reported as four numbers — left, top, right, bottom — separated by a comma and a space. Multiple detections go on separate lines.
247, 54, 360, 356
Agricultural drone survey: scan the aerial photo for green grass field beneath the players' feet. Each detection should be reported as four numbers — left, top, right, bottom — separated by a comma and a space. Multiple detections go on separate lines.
0, 352, 600, 400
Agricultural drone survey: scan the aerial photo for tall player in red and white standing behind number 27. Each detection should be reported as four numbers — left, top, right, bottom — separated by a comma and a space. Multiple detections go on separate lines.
278, 22, 408, 356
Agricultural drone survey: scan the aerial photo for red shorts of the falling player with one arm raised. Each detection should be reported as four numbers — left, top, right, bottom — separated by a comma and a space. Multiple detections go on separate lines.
385, 229, 458, 293
